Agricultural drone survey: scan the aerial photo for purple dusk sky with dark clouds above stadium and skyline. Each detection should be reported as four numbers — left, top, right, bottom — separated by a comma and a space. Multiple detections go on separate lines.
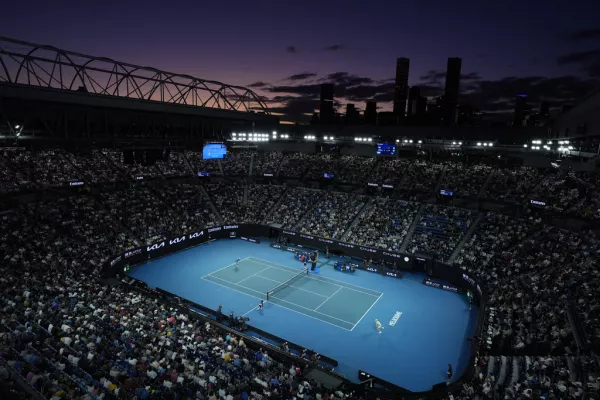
0, 0, 600, 120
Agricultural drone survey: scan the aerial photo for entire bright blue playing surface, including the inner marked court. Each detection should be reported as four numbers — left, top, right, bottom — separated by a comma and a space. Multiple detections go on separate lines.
129, 239, 477, 391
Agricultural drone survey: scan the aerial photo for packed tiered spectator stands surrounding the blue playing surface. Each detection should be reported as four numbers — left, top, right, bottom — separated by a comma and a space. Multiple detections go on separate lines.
0, 149, 600, 399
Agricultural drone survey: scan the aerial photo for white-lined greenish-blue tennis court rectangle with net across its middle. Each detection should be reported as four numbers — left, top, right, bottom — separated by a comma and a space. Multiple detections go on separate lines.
202, 257, 383, 331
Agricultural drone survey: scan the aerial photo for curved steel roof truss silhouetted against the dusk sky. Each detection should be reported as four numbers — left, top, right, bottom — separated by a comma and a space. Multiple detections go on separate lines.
0, 37, 270, 115
